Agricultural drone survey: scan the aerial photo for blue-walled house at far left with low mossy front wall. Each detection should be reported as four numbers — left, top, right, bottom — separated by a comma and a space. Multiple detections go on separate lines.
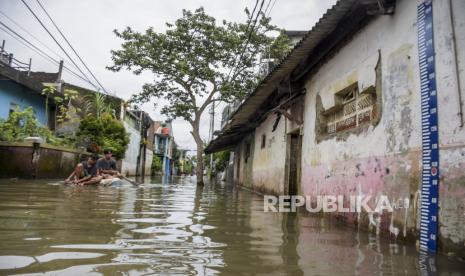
0, 48, 89, 179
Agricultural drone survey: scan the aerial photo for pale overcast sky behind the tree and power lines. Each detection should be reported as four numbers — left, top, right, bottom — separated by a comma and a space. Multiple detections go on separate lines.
0, 0, 336, 149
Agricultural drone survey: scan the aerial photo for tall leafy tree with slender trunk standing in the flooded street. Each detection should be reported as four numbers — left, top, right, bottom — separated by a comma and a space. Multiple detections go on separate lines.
108, 8, 288, 184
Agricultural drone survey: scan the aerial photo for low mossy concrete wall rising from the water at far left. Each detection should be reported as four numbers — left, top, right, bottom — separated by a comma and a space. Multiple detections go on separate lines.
0, 142, 90, 179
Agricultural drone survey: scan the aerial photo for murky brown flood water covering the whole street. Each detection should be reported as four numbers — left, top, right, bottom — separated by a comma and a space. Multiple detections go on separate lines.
0, 177, 465, 275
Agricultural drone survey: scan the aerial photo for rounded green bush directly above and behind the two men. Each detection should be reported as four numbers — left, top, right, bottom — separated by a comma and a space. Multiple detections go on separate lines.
76, 113, 129, 159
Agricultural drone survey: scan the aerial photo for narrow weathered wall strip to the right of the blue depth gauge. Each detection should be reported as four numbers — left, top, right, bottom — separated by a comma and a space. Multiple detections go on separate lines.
433, 0, 465, 256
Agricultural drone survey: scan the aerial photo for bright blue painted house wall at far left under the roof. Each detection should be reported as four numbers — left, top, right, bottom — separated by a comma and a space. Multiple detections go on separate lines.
0, 80, 47, 125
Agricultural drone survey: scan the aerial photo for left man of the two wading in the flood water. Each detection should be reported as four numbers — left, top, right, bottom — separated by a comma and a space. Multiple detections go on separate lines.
65, 153, 103, 185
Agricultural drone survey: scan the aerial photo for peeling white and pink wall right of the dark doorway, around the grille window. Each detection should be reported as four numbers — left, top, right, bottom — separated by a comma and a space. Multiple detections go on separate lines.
301, 0, 465, 254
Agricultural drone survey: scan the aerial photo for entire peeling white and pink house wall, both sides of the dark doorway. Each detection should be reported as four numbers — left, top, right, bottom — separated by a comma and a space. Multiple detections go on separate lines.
230, 0, 465, 256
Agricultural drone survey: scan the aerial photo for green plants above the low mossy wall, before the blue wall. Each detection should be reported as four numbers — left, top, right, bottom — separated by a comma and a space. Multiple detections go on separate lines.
0, 107, 54, 142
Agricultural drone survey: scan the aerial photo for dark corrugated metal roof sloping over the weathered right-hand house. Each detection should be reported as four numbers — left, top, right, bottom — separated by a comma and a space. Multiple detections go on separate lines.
205, 0, 390, 153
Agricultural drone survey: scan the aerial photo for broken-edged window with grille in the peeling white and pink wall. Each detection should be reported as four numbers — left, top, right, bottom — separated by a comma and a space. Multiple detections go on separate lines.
323, 85, 376, 135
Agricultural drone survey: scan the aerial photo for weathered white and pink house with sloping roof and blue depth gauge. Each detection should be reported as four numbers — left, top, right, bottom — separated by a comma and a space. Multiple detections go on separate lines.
205, 0, 465, 256
